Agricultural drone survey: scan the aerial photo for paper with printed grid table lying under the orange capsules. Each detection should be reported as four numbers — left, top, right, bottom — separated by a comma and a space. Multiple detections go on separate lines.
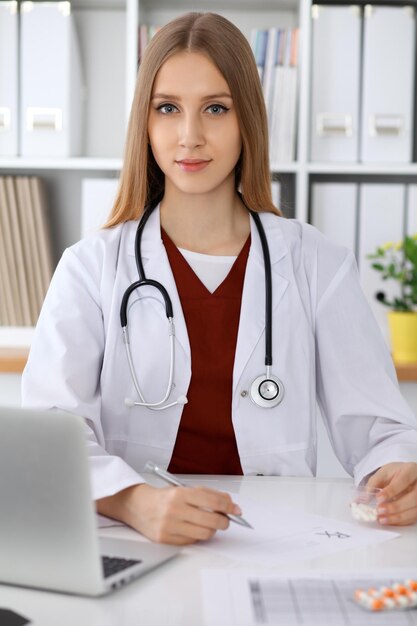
202, 569, 417, 626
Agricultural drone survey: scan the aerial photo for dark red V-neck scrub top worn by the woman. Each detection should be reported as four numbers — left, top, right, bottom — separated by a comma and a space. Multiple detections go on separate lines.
162, 230, 250, 474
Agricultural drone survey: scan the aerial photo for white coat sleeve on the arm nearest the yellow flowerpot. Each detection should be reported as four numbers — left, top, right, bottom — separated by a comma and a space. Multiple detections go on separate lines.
316, 252, 417, 483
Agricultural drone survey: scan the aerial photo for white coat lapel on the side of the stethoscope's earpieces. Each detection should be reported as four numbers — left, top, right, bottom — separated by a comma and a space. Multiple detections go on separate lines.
129, 206, 191, 360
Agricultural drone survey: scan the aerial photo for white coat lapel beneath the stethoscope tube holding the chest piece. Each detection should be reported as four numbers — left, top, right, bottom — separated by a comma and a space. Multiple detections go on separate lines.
233, 213, 289, 390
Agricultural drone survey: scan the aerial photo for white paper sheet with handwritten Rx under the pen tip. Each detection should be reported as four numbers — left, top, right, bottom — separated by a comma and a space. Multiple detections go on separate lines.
193, 496, 399, 565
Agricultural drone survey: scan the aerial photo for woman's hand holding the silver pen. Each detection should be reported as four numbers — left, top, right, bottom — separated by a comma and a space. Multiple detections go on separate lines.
97, 483, 241, 545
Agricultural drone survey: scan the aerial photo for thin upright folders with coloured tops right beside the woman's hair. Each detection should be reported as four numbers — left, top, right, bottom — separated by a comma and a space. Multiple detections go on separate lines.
251, 28, 299, 163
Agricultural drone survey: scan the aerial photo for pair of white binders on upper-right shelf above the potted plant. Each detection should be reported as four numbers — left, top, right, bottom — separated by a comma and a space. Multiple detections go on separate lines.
310, 3, 415, 163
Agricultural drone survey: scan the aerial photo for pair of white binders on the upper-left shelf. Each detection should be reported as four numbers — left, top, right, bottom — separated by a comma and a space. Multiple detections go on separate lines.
0, 0, 85, 158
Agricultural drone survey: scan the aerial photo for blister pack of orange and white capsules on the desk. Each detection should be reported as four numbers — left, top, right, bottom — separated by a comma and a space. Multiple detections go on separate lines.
353, 579, 417, 611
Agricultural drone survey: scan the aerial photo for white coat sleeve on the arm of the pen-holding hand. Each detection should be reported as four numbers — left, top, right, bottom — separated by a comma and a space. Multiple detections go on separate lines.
22, 244, 143, 499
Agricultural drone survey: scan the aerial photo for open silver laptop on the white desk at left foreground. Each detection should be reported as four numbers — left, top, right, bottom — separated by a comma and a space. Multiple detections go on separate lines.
0, 407, 179, 596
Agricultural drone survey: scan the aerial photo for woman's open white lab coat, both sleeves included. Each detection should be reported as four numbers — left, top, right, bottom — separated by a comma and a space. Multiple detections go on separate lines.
22, 208, 417, 498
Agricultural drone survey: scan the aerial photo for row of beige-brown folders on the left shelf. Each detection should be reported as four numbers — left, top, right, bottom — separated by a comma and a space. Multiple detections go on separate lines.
0, 176, 52, 326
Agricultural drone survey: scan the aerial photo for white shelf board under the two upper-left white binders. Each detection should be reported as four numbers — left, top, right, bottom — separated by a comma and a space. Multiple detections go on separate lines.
0, 157, 122, 172
